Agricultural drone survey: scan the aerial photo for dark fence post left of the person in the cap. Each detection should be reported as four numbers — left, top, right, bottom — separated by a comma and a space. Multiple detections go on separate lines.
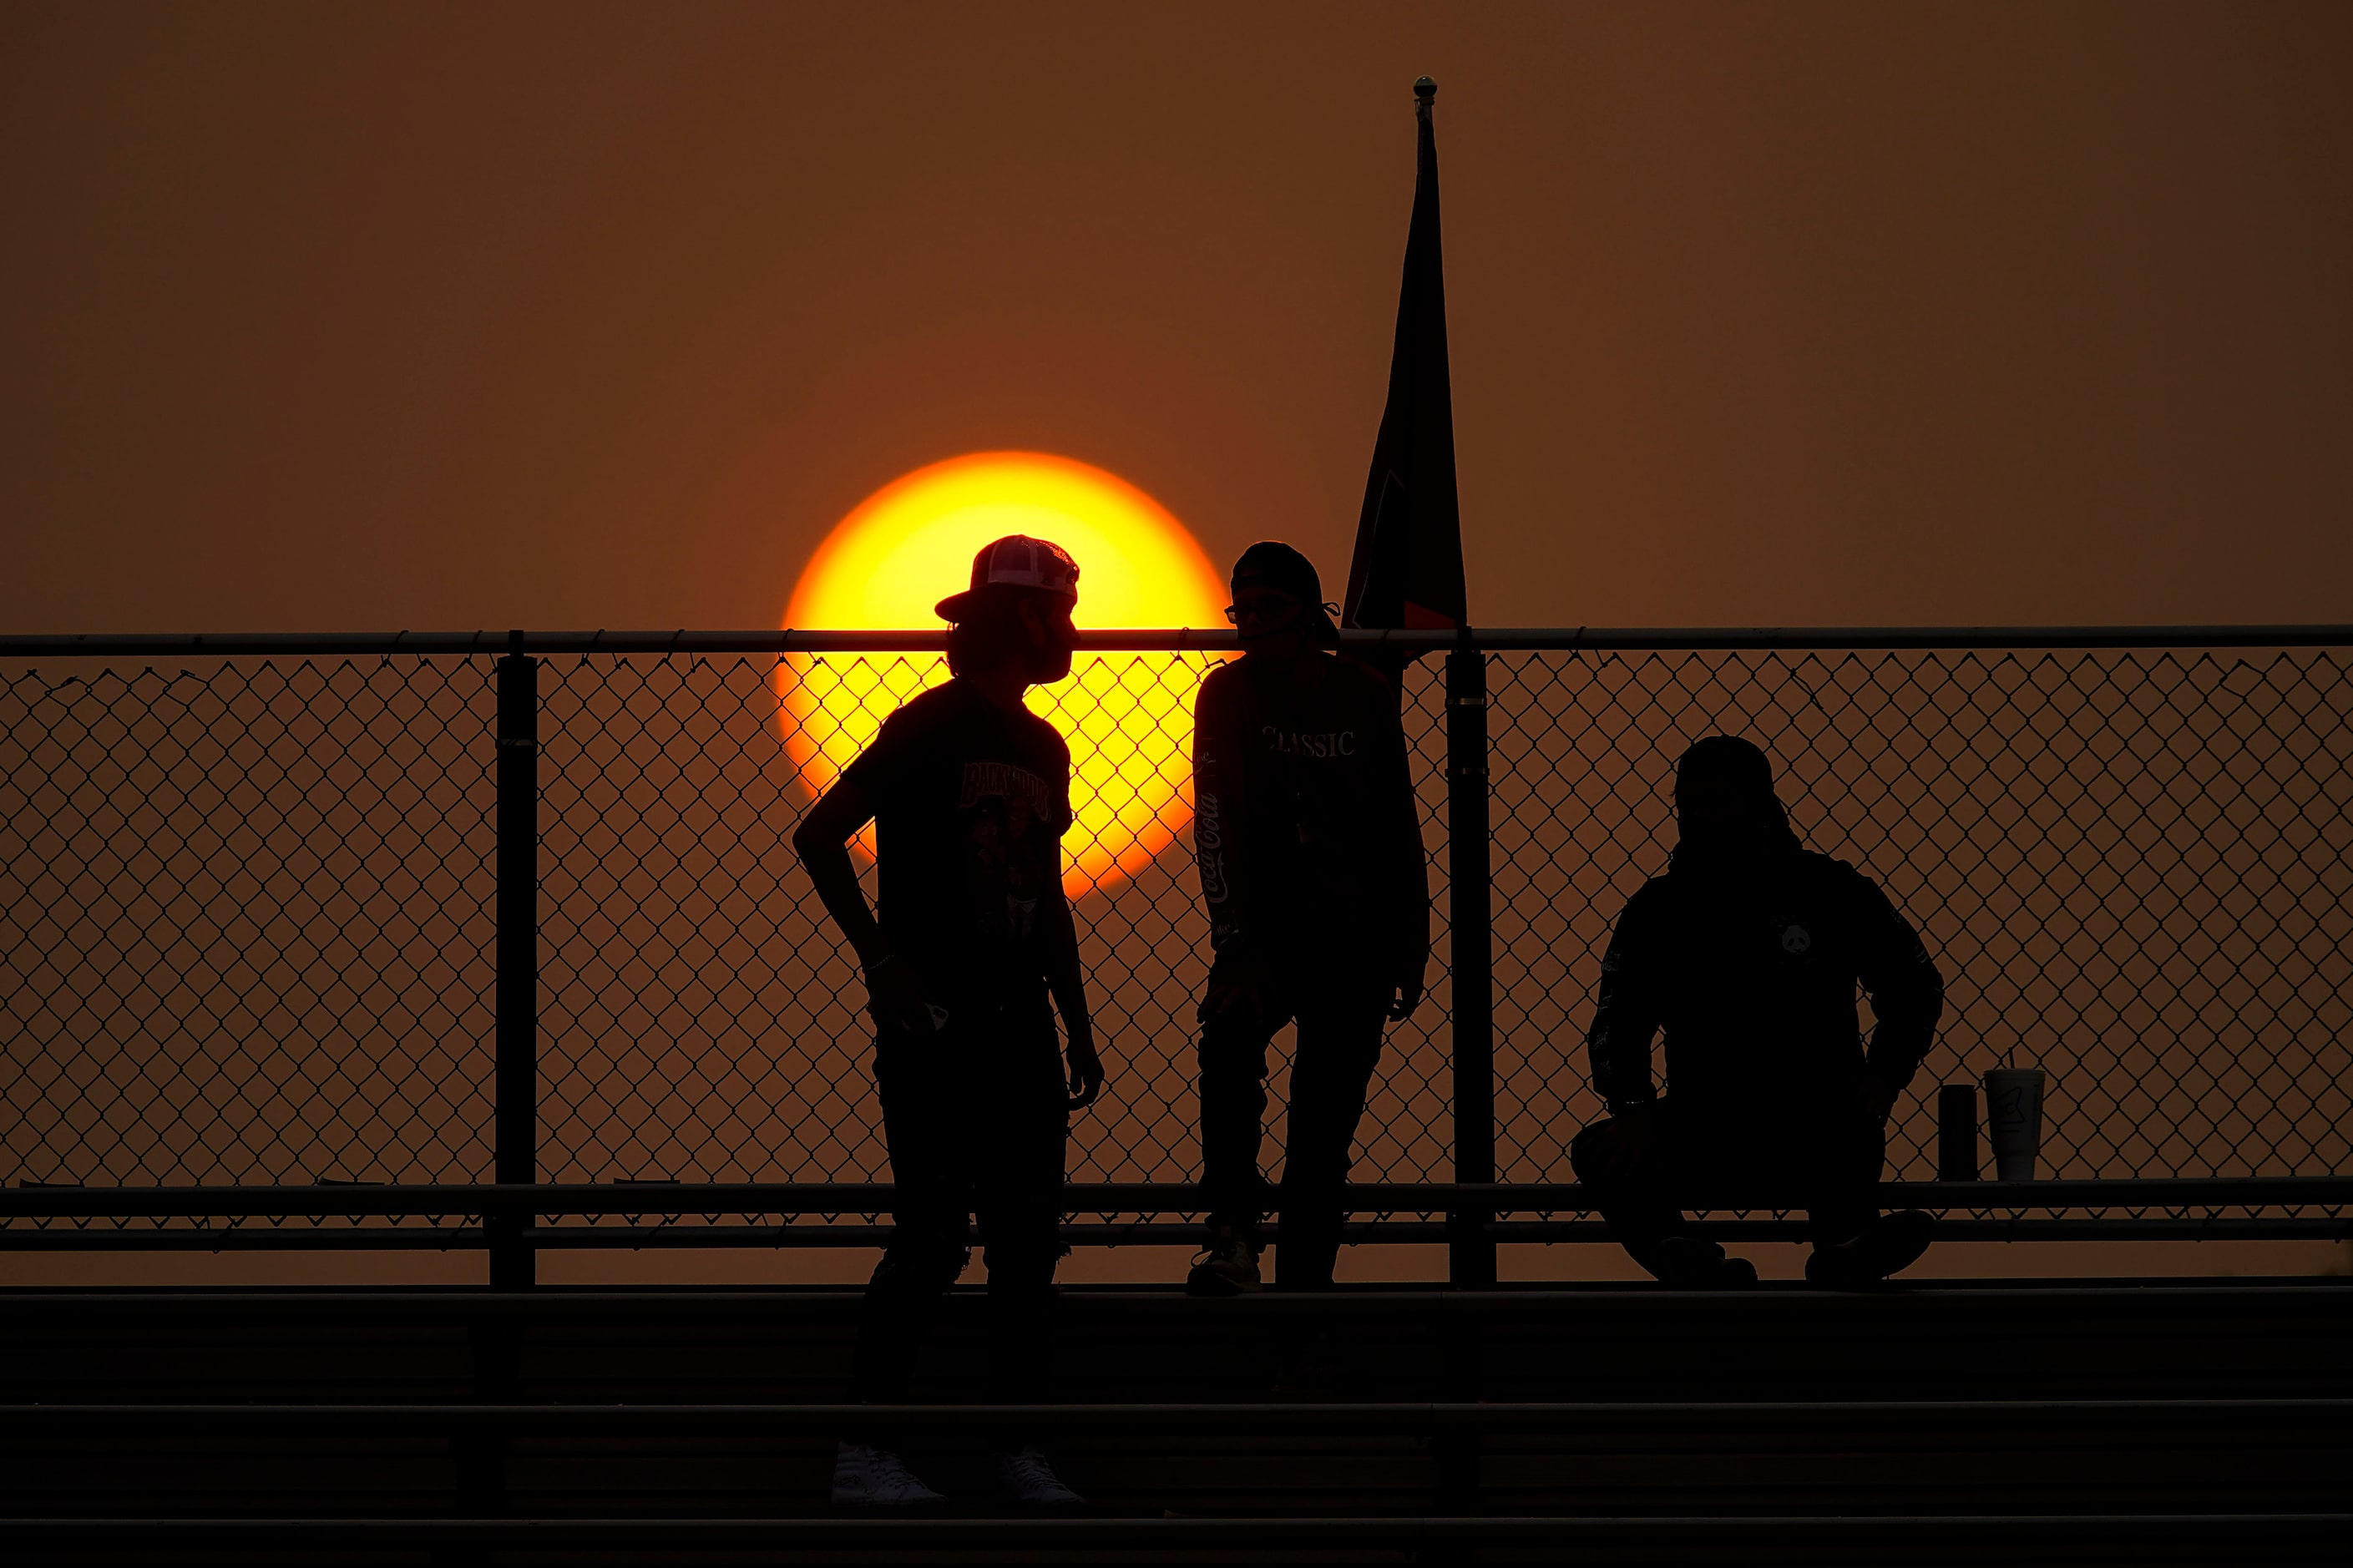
483, 631, 539, 1290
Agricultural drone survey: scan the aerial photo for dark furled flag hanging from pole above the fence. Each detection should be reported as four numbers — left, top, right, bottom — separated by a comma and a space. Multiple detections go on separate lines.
1341, 78, 1468, 675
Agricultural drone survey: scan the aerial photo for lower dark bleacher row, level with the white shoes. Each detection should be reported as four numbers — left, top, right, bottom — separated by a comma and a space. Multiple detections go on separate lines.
13, 1399, 2353, 1516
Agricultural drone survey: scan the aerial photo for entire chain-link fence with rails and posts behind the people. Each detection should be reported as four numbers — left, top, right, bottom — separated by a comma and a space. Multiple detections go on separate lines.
0, 626, 2353, 1278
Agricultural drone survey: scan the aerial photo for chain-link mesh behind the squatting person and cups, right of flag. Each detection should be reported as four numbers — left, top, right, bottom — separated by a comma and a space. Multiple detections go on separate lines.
1490, 650, 2353, 1180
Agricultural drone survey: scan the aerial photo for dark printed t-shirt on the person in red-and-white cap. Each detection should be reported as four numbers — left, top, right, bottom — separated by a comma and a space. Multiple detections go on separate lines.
843, 680, 1070, 1013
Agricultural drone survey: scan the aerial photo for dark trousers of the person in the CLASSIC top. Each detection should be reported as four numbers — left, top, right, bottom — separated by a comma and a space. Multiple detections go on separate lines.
1200, 953, 1393, 1290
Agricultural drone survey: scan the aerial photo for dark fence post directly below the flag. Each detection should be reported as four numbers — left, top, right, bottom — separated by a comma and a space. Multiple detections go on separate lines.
1447, 629, 1494, 1287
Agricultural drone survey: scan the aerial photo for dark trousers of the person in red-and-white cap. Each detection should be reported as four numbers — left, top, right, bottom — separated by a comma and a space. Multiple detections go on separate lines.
852, 999, 1068, 1404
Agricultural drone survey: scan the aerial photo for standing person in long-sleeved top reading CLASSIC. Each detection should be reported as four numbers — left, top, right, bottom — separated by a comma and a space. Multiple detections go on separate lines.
1186, 542, 1430, 1295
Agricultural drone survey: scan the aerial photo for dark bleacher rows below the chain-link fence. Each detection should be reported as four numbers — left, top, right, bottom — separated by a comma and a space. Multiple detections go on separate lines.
0, 1281, 2353, 1563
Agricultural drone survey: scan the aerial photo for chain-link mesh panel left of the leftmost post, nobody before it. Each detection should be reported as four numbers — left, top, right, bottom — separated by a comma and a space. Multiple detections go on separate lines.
0, 660, 497, 1184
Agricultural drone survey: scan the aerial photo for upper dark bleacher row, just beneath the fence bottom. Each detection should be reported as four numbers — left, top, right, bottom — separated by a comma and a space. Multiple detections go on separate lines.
0, 1278, 2353, 1404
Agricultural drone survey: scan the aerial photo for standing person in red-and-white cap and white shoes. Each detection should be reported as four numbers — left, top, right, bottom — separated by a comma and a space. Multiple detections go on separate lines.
793, 534, 1104, 1507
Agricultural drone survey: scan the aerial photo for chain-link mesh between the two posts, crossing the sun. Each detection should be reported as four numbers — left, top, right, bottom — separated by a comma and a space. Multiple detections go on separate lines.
541, 655, 1452, 1182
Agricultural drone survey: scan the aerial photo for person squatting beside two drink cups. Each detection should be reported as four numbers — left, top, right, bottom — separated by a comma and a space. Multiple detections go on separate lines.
1570, 735, 1944, 1287
